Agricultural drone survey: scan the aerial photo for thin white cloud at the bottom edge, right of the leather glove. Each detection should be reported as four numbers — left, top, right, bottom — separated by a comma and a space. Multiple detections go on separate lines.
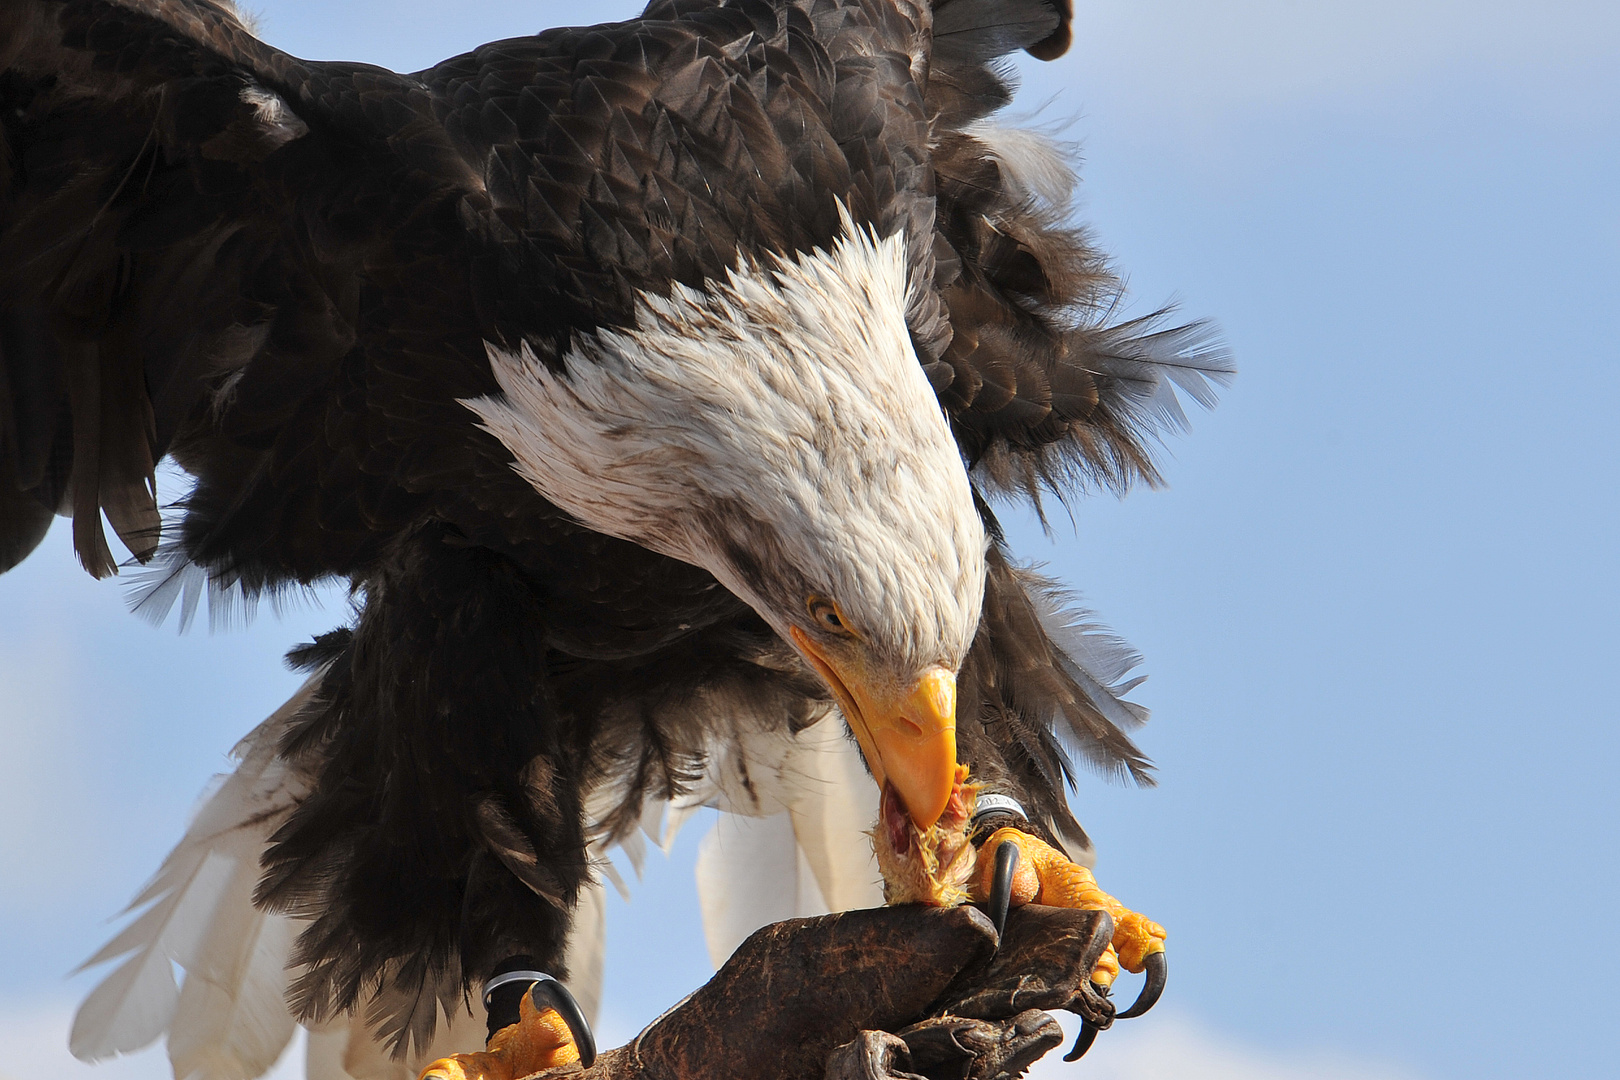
1029, 1012, 1418, 1080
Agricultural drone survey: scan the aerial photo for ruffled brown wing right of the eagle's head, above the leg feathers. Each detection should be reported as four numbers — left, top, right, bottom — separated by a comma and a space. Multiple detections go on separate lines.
928, 0, 1231, 505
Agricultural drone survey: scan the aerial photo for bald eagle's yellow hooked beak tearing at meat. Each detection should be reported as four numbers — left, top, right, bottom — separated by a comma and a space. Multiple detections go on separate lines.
791, 627, 956, 832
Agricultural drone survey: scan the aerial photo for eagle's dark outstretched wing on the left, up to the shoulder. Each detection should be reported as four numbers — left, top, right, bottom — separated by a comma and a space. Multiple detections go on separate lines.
0, 0, 557, 591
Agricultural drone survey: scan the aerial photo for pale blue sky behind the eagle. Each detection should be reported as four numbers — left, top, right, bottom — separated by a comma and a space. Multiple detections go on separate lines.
0, 0, 1620, 1080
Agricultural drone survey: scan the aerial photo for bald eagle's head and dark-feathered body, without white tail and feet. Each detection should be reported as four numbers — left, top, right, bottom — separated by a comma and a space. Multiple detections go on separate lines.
0, 0, 1230, 1075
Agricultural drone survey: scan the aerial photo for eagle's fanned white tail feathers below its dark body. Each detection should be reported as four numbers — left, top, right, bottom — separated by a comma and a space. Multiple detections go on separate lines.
71, 678, 881, 1080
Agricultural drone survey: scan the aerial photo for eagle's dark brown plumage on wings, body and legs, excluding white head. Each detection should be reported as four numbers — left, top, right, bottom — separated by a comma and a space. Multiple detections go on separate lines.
0, 0, 1226, 1062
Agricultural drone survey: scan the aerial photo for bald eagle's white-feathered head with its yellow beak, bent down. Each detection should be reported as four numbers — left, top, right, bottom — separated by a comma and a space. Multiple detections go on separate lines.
467, 227, 985, 829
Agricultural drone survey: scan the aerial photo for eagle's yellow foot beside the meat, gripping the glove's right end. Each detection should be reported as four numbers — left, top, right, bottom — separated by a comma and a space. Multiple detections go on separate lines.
974, 829, 1165, 990
